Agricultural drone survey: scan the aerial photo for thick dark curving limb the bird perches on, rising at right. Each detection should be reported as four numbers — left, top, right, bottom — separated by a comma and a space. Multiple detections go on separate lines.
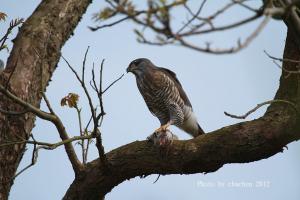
64, 28, 300, 200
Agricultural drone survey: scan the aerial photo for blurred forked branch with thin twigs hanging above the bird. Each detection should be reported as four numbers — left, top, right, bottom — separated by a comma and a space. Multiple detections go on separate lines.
91, 0, 300, 54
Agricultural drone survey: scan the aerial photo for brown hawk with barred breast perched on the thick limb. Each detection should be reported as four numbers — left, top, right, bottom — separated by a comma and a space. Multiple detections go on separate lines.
127, 58, 204, 141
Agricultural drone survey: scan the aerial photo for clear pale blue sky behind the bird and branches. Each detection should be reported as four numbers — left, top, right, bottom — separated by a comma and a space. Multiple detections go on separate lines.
0, 0, 300, 200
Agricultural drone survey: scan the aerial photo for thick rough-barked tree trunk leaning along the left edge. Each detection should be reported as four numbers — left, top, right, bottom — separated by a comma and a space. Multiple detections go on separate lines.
0, 0, 91, 200
